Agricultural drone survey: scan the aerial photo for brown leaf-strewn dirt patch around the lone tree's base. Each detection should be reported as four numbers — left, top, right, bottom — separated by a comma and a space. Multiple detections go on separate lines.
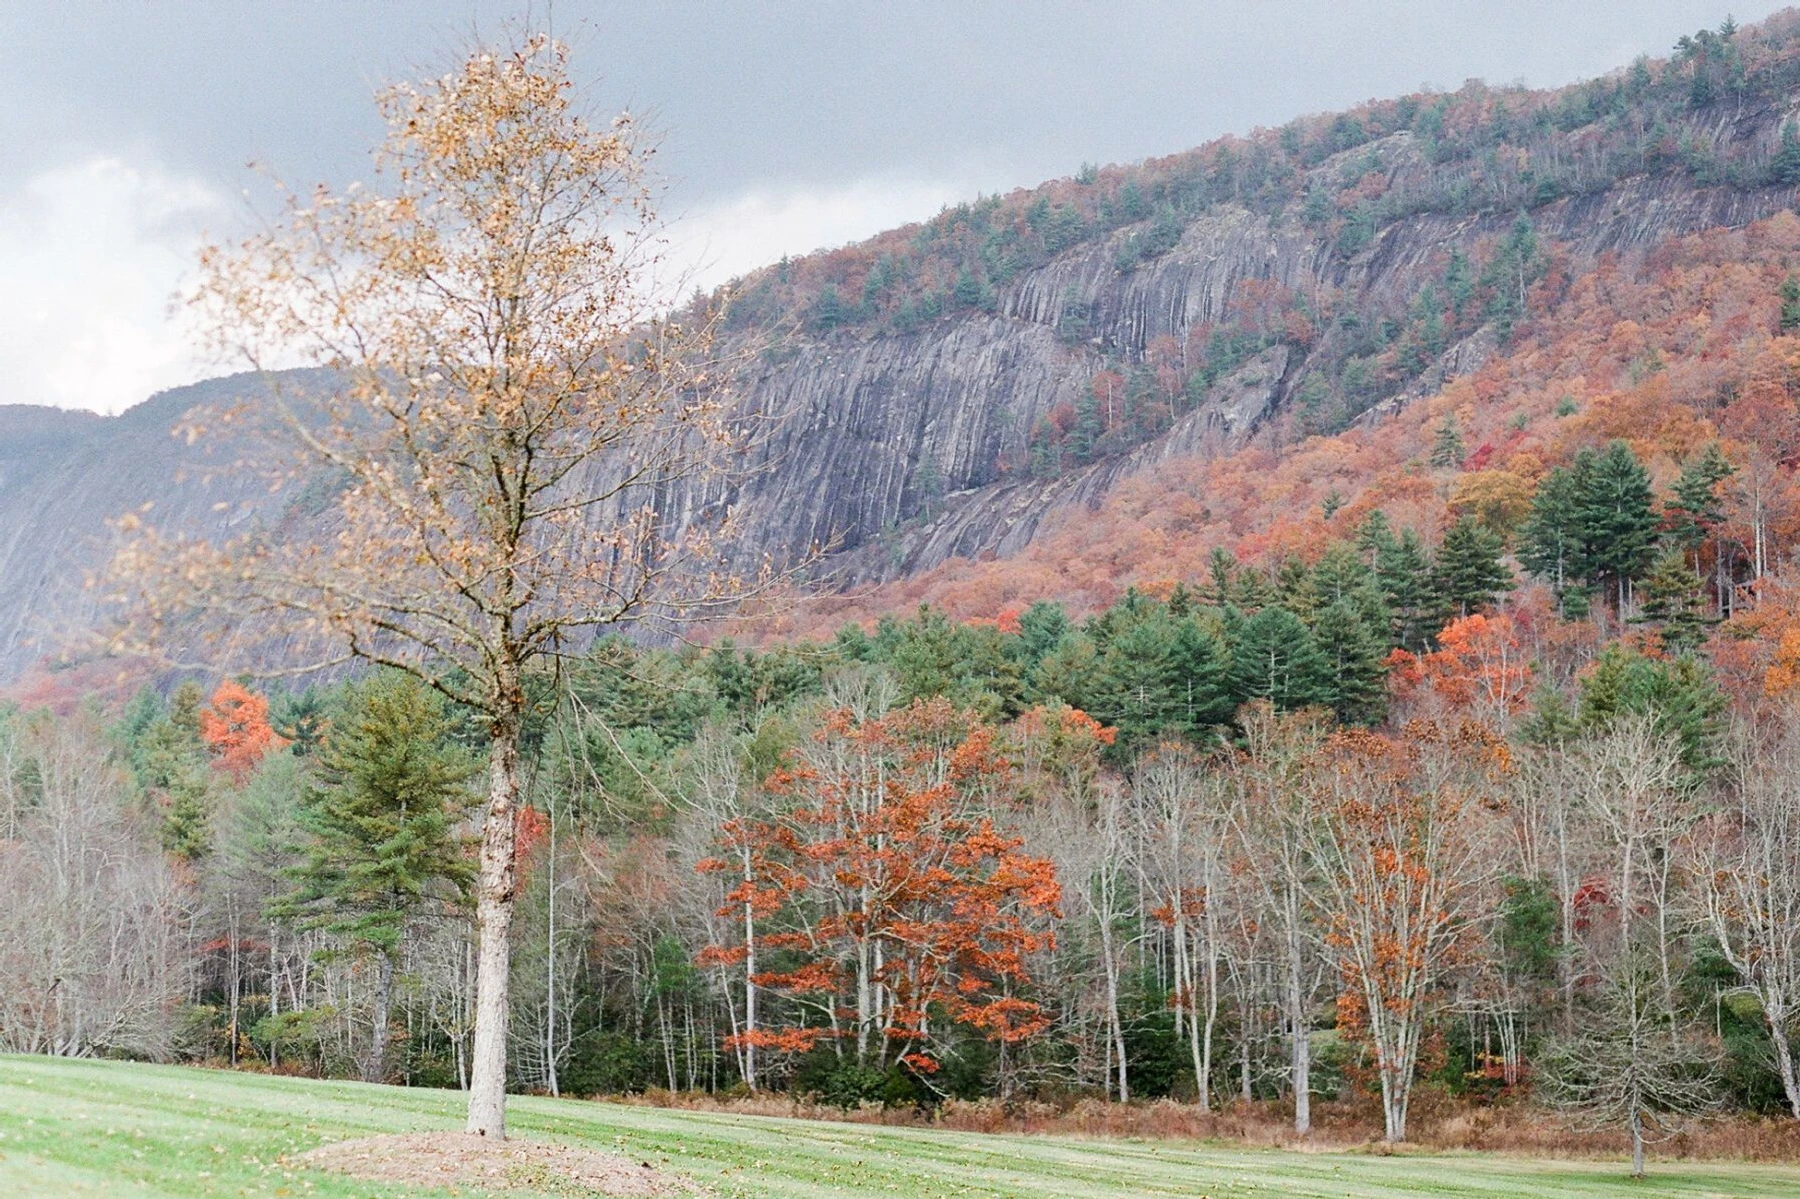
292, 1132, 693, 1199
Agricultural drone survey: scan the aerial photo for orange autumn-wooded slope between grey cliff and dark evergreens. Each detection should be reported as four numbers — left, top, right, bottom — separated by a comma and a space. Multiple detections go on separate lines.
781, 211, 1800, 634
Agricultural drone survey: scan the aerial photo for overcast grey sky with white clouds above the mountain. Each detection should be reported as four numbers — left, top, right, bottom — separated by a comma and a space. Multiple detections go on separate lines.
0, 0, 1782, 412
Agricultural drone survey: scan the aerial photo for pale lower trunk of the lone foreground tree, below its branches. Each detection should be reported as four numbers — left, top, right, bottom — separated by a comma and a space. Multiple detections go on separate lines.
468, 718, 518, 1140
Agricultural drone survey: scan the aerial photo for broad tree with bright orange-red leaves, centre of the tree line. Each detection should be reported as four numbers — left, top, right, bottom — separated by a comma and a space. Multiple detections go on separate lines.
704, 699, 1060, 1078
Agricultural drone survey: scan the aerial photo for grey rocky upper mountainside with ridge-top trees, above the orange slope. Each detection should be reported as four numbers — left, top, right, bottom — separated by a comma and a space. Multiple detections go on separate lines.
0, 13, 1800, 677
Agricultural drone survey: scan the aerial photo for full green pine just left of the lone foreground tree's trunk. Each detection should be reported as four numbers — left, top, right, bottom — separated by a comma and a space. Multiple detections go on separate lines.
281, 672, 477, 1080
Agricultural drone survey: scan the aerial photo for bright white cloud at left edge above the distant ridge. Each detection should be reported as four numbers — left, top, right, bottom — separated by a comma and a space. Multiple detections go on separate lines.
0, 157, 223, 412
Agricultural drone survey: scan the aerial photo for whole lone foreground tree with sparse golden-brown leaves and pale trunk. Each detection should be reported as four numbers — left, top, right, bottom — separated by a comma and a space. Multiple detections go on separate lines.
100, 36, 774, 1136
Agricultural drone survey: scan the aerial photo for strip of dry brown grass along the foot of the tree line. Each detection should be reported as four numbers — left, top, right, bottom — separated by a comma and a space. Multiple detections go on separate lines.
617, 1089, 1800, 1163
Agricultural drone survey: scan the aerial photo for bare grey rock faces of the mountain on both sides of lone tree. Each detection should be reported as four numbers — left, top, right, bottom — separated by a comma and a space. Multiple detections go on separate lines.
0, 79, 1795, 679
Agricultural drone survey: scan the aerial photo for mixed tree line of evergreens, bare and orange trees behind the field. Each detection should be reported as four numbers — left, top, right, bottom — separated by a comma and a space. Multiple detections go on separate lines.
0, 417, 1800, 1159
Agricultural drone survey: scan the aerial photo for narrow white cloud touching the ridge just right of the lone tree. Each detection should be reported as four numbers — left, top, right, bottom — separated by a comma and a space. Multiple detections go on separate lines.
668, 180, 974, 298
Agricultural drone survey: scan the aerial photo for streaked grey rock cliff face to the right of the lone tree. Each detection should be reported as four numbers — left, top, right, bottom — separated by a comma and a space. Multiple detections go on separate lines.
705, 135, 1796, 583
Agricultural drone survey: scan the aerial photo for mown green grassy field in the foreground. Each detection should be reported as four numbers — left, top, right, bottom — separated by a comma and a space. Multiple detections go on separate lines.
0, 1057, 1800, 1199
